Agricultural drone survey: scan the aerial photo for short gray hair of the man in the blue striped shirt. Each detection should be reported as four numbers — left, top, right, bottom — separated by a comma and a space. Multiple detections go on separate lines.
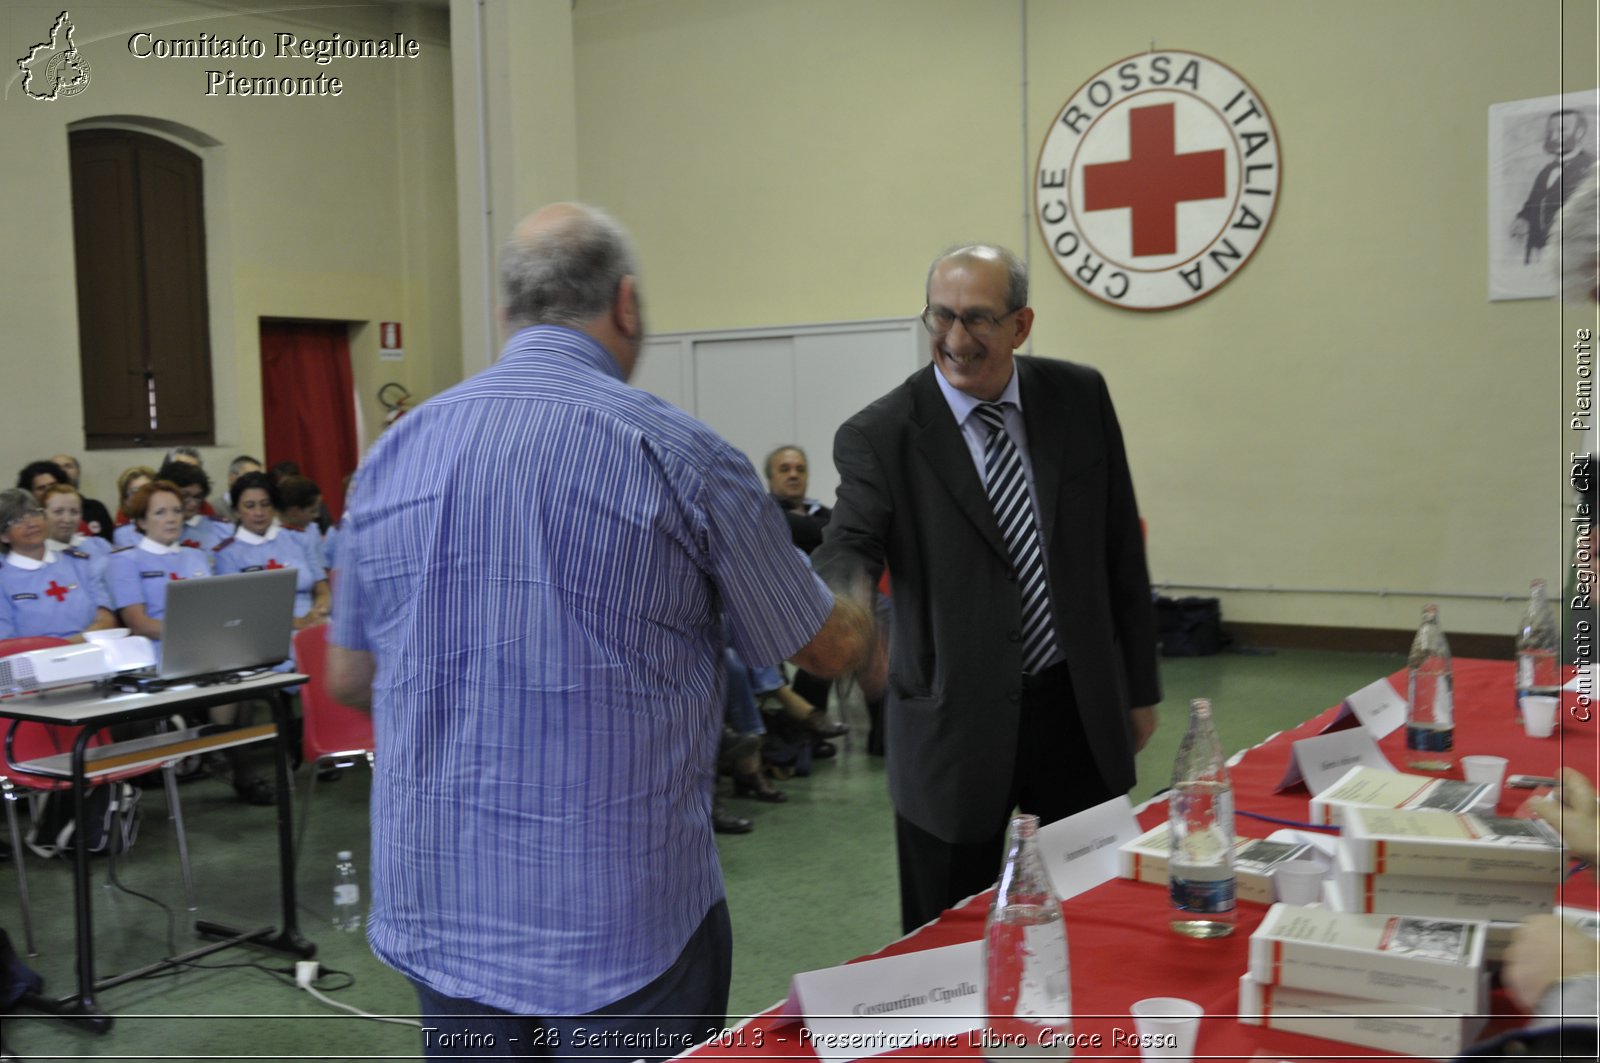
501, 207, 638, 331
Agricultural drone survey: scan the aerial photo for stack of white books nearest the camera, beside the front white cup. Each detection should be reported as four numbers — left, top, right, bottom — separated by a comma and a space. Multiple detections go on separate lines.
1238, 905, 1488, 1060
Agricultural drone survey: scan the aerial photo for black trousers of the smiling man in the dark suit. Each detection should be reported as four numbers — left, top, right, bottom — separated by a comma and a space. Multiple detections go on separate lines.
890, 663, 1115, 933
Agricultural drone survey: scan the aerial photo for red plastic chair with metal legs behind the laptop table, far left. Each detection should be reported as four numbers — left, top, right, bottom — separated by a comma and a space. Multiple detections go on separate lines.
0, 636, 194, 956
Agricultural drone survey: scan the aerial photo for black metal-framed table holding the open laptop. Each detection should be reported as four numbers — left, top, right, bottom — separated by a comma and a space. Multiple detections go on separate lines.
0, 672, 317, 1033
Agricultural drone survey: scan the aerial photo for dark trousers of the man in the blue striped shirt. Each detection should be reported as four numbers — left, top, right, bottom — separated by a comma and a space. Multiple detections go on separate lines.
413, 901, 733, 1061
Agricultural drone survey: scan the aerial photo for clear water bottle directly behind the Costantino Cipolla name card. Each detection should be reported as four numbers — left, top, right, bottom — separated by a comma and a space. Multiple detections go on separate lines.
979, 815, 1072, 1060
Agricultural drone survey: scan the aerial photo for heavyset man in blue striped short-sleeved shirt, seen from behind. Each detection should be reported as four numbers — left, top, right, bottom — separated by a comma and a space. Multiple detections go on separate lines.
328, 203, 870, 1058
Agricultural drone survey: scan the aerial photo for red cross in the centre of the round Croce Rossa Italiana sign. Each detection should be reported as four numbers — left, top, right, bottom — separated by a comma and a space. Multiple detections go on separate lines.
1083, 104, 1227, 255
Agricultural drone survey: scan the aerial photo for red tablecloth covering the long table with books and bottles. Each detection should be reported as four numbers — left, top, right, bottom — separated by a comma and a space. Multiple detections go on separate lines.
693, 660, 1600, 1060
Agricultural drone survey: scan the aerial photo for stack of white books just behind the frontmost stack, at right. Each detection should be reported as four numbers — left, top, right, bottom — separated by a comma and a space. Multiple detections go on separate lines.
1325, 805, 1566, 922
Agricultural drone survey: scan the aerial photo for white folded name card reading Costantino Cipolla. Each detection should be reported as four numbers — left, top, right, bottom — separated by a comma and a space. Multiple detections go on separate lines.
782, 941, 979, 1061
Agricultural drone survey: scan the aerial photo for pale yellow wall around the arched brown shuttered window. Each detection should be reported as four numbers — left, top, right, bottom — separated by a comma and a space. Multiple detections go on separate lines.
0, 0, 459, 501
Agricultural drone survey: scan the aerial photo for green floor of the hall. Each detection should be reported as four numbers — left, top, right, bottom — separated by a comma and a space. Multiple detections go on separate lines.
0, 650, 1405, 1060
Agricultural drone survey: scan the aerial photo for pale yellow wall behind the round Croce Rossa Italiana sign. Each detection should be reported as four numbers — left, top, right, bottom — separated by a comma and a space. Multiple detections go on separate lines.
574, 0, 1597, 632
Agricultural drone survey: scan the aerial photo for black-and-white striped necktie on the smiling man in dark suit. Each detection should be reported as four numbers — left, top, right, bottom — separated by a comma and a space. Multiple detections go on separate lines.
974, 402, 1056, 672
